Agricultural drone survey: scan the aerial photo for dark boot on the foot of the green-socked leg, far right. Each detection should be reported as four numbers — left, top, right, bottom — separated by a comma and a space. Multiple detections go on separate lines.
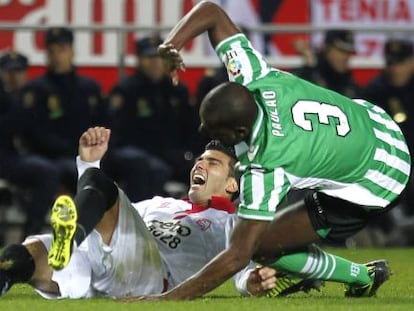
345, 260, 391, 297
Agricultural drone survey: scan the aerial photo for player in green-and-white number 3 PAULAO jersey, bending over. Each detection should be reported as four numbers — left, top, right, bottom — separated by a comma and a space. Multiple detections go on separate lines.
132, 2, 411, 299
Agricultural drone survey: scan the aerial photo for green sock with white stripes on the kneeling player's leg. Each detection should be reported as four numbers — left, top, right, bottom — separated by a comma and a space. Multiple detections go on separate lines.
270, 245, 372, 285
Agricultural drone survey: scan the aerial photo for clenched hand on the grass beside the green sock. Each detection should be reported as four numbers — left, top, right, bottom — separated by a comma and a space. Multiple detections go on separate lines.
247, 267, 276, 296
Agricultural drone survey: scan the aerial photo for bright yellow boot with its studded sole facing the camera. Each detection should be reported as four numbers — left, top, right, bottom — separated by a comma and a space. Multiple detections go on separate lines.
48, 195, 78, 270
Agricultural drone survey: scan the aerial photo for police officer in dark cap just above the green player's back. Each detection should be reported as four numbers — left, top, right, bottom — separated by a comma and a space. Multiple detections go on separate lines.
293, 30, 361, 98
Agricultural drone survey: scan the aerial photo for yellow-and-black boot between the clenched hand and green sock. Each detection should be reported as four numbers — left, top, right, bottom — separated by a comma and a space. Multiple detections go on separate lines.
266, 274, 325, 298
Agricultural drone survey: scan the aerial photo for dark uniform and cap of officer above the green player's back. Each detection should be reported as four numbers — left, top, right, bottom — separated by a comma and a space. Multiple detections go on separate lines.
293, 30, 361, 98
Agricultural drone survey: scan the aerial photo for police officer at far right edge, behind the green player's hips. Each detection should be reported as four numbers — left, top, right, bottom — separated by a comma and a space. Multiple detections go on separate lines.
363, 38, 414, 246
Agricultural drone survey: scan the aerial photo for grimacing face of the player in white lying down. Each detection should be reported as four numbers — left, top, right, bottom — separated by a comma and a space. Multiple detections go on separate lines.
188, 150, 238, 206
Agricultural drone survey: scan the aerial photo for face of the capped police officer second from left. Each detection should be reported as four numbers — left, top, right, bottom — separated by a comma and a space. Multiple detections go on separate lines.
47, 43, 74, 73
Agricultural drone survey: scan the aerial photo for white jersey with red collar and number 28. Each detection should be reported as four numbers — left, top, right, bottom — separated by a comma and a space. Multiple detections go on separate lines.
133, 197, 236, 288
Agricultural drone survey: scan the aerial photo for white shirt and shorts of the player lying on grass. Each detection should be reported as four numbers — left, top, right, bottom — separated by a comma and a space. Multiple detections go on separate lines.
29, 160, 254, 298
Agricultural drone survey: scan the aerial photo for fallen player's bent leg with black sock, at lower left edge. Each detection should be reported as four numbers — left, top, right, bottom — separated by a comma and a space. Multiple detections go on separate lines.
0, 240, 59, 295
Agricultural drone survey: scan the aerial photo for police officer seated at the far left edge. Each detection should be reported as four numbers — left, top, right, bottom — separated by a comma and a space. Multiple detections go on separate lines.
0, 52, 58, 236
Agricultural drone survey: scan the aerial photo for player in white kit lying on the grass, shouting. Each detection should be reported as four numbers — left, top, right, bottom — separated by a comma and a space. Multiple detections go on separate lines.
0, 128, 275, 298
